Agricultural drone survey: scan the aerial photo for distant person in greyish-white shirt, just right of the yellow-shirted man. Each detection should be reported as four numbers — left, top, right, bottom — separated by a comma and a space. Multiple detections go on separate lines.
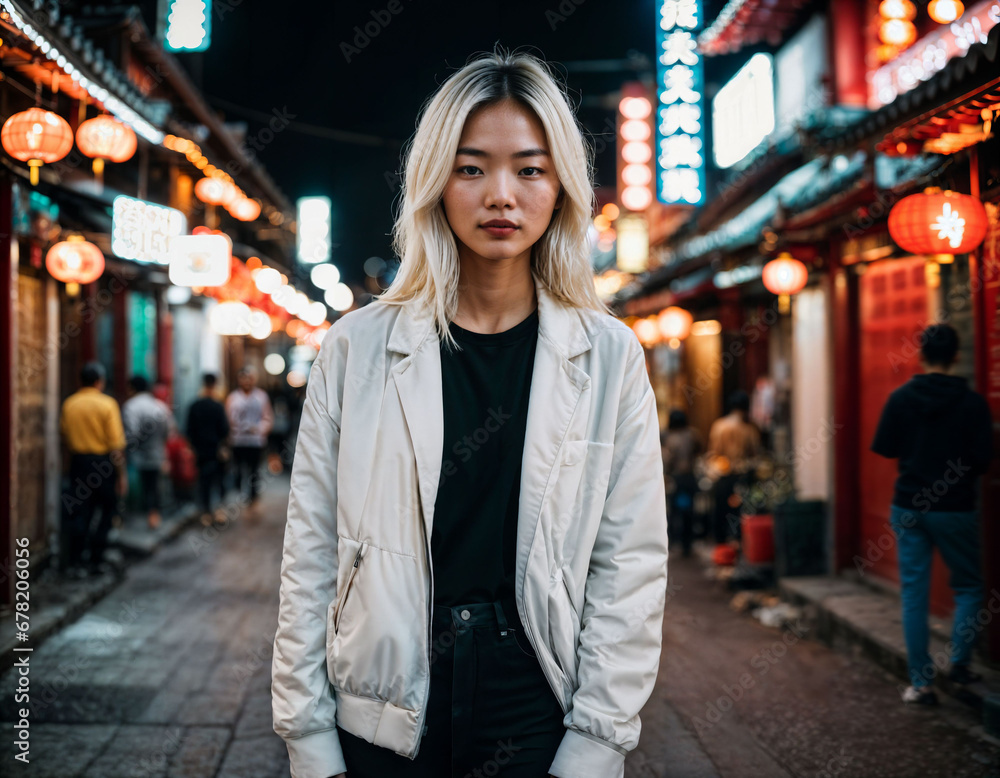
122, 375, 174, 529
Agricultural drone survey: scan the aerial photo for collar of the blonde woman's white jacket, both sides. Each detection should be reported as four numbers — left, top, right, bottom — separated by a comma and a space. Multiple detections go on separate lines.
388, 273, 591, 359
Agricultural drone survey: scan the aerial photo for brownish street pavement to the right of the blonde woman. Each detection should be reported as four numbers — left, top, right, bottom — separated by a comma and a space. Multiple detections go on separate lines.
626, 556, 1000, 778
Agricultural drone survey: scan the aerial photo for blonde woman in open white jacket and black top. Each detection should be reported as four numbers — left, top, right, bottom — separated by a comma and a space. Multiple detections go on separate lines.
272, 48, 667, 778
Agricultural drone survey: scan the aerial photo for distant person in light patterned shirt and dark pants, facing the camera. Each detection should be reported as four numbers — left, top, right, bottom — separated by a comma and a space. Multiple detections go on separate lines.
226, 365, 274, 505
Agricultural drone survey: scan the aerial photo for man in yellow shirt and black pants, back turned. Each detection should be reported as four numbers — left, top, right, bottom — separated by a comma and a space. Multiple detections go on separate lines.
59, 362, 128, 577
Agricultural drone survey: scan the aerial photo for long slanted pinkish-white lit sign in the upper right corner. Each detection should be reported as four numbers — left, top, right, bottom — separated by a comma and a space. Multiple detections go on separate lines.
868, 0, 1000, 110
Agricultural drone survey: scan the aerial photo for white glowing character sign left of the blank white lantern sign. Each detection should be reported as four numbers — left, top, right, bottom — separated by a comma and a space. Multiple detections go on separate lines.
111, 195, 187, 265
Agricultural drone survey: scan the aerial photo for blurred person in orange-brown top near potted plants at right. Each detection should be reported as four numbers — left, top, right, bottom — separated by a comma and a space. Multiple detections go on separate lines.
706, 390, 760, 543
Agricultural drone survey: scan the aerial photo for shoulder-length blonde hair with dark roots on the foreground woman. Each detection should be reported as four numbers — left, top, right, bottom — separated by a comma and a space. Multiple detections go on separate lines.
377, 47, 610, 347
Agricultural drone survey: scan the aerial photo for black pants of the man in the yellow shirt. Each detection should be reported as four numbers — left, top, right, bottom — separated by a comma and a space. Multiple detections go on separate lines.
63, 454, 118, 567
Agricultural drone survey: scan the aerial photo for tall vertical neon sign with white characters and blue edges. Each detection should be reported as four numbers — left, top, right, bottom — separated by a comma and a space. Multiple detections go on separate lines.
656, 0, 705, 205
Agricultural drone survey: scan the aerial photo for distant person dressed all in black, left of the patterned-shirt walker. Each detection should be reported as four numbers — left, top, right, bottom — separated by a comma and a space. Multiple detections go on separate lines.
187, 373, 229, 525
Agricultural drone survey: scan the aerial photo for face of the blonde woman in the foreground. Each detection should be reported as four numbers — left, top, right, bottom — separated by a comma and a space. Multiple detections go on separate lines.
443, 100, 562, 268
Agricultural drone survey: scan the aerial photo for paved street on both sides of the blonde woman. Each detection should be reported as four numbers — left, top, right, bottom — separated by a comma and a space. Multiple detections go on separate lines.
0, 477, 1000, 778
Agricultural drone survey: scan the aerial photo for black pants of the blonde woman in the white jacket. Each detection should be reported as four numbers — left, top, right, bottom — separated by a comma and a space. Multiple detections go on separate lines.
337, 602, 566, 778
